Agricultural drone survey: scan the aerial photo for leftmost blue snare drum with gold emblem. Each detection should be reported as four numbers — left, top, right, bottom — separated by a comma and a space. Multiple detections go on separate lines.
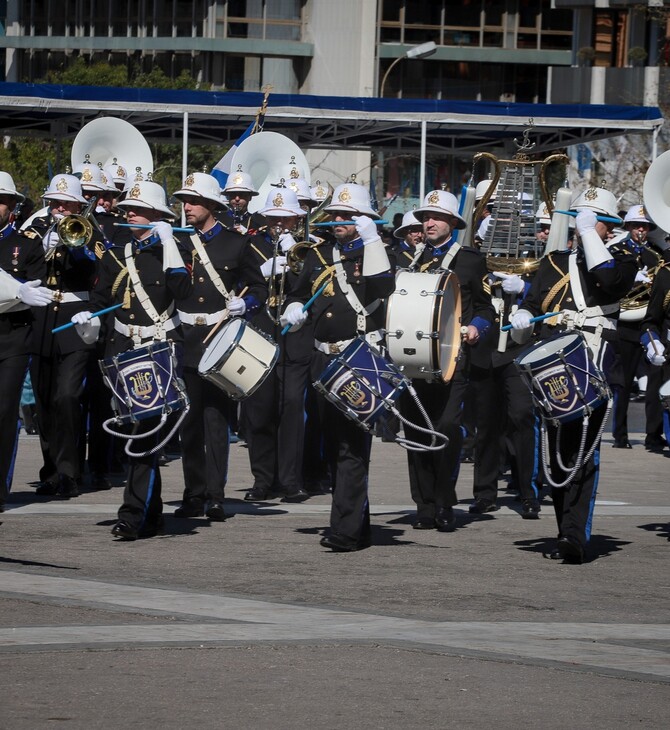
99, 342, 188, 425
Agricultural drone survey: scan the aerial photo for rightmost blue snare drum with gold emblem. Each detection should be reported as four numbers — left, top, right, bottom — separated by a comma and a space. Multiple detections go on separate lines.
514, 332, 612, 423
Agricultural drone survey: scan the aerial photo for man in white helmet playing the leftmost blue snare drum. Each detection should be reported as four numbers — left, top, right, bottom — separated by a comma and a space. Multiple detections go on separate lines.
72, 181, 191, 540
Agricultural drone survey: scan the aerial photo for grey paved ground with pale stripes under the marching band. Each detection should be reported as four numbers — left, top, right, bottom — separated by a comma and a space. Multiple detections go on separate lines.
0, 404, 670, 730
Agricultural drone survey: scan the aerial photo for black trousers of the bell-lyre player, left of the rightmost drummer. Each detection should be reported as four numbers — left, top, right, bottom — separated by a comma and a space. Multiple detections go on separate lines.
470, 362, 540, 501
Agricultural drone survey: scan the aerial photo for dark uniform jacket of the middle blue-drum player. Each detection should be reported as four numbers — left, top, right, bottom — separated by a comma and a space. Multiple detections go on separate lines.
288, 233, 395, 346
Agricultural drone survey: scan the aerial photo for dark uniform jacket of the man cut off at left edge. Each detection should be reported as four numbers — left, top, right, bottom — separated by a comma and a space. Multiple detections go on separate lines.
0, 223, 46, 360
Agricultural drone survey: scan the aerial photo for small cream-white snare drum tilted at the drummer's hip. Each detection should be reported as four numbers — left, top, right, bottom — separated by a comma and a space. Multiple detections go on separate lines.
198, 317, 279, 400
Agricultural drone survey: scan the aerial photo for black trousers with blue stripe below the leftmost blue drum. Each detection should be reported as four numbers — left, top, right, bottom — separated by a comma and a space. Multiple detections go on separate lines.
118, 417, 165, 531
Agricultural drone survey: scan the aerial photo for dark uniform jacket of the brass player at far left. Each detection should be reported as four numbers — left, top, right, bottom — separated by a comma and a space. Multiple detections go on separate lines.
28, 215, 102, 357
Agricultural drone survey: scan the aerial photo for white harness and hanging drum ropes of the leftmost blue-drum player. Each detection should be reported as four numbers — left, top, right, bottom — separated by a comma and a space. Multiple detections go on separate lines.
102, 243, 191, 458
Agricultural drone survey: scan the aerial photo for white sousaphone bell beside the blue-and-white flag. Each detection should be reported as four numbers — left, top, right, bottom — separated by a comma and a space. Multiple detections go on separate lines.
230, 132, 311, 213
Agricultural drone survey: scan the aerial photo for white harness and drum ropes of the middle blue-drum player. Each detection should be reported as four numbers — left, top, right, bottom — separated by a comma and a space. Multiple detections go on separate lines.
315, 246, 449, 451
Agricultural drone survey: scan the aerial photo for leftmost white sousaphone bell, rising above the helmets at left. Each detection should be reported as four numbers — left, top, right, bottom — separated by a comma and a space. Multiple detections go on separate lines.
70, 117, 154, 180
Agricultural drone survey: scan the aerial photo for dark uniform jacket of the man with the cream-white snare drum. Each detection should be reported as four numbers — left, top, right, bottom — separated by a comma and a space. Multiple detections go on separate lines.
177, 221, 267, 368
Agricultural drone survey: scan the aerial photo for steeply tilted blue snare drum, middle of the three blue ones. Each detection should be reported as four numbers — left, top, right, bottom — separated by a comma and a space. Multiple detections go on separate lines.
314, 337, 408, 431
